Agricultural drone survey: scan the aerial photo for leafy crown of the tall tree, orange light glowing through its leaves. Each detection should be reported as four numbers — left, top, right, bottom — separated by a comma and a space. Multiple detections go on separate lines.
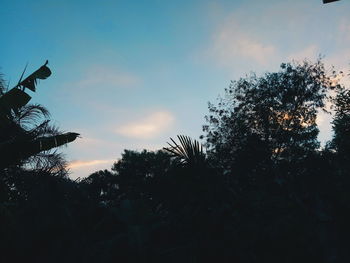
203, 59, 334, 175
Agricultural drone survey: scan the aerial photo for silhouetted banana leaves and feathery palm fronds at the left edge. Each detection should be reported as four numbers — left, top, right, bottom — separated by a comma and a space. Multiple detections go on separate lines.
0, 61, 79, 170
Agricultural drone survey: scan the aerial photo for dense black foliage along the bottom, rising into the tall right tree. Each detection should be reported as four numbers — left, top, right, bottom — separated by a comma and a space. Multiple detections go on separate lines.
0, 60, 350, 263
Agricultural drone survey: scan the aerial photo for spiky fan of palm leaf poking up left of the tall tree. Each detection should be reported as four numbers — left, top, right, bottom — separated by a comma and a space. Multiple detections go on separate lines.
163, 135, 205, 165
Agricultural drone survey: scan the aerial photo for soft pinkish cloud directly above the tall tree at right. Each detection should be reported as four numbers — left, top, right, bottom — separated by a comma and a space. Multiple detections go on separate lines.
212, 19, 276, 65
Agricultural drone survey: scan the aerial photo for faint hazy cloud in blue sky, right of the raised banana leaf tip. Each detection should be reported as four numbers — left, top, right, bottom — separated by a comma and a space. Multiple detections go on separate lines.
55, 65, 143, 114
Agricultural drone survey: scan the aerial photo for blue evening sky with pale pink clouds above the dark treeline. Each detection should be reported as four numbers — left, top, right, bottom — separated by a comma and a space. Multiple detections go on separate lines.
0, 0, 350, 179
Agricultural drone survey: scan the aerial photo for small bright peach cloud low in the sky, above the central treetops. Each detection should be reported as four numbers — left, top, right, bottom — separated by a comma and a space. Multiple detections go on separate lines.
115, 111, 175, 139
